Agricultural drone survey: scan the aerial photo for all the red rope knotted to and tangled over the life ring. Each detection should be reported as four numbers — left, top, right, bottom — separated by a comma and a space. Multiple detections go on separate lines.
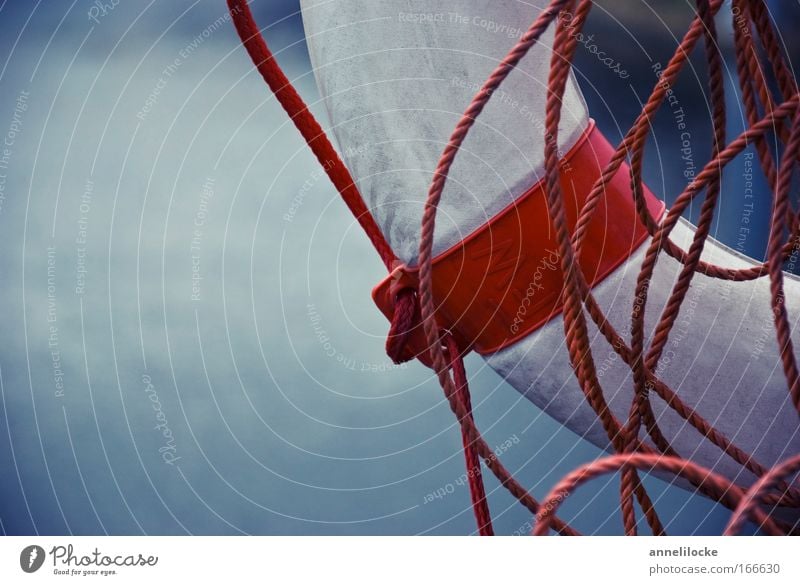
228, 0, 800, 535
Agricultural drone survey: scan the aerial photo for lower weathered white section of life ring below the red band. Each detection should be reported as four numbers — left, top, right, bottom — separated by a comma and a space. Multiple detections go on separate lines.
487, 222, 800, 484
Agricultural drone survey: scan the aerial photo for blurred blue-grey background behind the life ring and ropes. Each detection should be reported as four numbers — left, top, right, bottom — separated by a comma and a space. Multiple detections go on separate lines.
0, 0, 798, 534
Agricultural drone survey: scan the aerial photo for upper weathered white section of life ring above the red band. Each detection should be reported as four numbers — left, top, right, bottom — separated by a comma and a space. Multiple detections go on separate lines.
301, 0, 588, 263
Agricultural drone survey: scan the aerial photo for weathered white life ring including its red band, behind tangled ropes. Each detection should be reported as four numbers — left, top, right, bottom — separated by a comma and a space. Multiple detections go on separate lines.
301, 0, 800, 512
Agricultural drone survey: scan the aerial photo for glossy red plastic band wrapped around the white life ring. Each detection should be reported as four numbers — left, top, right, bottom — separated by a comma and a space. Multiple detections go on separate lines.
372, 121, 664, 361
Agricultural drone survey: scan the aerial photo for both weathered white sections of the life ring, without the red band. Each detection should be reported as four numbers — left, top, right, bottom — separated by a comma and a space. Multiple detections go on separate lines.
302, 0, 800, 492
